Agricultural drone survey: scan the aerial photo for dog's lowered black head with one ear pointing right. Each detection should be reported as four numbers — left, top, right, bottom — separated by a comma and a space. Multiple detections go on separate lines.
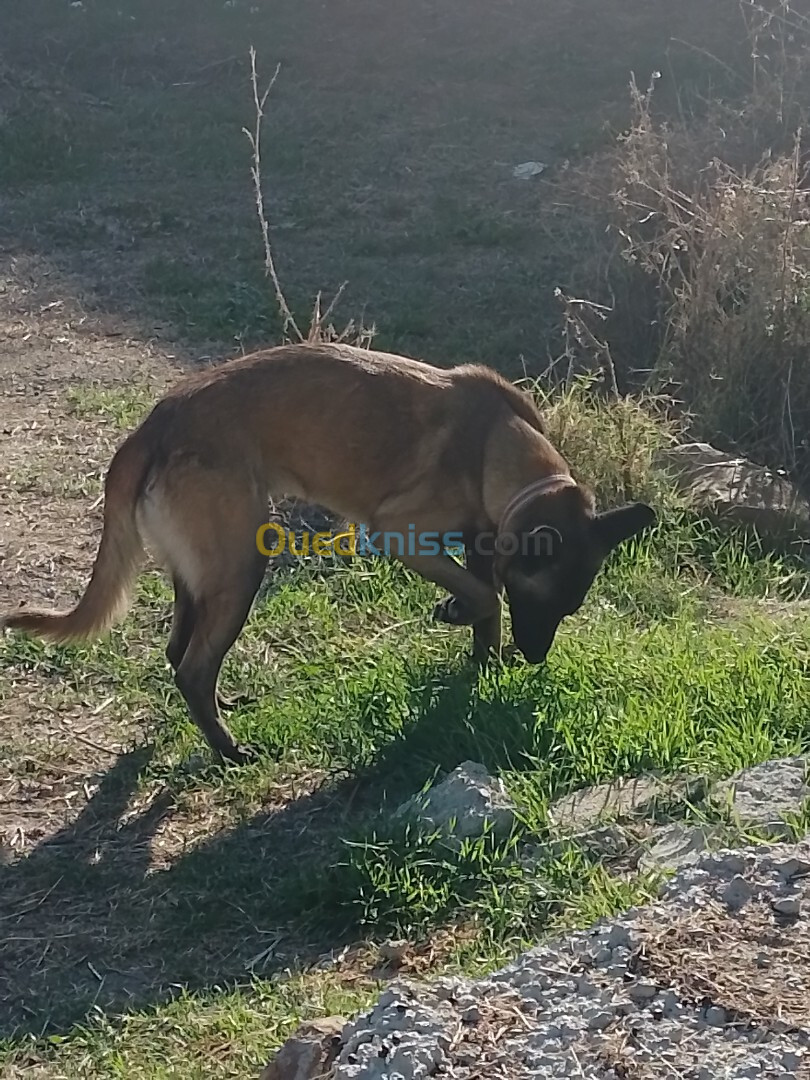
494, 484, 656, 663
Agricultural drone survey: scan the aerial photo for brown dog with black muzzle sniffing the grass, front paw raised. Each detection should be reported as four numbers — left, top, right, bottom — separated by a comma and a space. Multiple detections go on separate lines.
4, 345, 656, 761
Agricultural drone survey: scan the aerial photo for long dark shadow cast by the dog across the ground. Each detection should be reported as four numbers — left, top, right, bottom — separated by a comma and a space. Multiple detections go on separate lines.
0, 656, 565, 1038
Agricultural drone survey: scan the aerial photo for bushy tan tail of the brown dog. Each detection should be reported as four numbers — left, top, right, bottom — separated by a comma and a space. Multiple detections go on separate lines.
0, 433, 150, 642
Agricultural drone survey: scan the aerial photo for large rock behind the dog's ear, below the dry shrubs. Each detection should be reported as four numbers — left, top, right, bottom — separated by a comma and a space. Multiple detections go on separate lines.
654, 443, 810, 537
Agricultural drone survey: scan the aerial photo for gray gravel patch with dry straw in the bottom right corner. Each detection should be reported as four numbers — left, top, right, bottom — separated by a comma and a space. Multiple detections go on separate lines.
330, 840, 810, 1080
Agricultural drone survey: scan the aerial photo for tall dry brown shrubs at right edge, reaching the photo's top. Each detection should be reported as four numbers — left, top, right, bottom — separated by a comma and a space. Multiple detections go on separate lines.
558, 0, 810, 486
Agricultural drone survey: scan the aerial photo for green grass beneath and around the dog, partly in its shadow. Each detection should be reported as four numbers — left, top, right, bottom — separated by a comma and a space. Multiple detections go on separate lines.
0, 509, 810, 1077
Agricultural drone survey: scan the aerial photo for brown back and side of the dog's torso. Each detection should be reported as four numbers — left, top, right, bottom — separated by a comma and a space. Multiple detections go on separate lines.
135, 336, 543, 521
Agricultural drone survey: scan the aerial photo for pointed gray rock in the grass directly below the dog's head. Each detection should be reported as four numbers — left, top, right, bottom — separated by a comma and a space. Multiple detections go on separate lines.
396, 761, 515, 841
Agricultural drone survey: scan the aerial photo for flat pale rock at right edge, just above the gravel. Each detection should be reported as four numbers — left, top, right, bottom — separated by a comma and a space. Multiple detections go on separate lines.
712, 757, 810, 839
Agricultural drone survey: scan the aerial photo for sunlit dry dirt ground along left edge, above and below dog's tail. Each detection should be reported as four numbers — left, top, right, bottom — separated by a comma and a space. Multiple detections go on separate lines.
0, 248, 185, 854
